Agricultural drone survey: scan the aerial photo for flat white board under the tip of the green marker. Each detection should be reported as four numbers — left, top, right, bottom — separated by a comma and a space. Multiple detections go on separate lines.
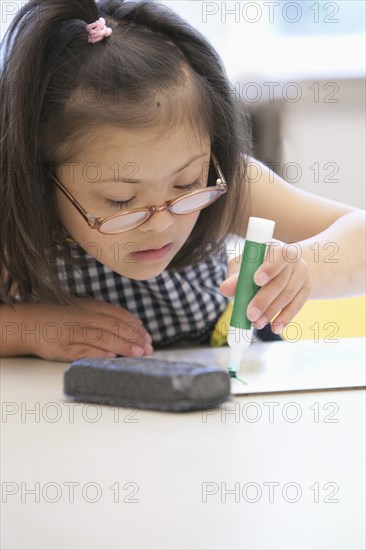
153, 338, 366, 395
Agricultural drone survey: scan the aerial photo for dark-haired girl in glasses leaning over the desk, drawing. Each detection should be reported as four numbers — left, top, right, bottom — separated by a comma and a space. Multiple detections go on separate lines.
0, 0, 365, 361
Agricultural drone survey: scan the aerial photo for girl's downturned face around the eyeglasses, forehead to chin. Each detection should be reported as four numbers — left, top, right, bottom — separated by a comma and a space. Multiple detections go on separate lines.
56, 127, 211, 280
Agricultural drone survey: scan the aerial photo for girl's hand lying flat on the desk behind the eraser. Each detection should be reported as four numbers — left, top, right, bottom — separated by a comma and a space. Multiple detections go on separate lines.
22, 299, 153, 361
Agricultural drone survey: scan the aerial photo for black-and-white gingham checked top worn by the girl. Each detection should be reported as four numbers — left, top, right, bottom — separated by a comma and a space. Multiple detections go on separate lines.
56, 239, 228, 347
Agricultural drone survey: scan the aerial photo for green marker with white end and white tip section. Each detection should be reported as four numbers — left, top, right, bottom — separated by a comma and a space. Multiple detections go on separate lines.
227, 217, 275, 378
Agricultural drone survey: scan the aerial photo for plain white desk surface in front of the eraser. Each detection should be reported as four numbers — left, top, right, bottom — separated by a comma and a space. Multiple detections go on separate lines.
0, 339, 365, 550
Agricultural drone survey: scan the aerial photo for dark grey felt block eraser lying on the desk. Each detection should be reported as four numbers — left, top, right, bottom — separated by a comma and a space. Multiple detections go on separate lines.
64, 357, 230, 411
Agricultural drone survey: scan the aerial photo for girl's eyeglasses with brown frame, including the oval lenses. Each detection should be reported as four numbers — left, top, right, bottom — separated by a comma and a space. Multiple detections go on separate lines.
49, 153, 227, 235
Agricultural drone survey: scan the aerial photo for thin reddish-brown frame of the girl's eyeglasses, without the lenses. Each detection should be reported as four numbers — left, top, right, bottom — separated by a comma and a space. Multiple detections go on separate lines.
48, 152, 228, 235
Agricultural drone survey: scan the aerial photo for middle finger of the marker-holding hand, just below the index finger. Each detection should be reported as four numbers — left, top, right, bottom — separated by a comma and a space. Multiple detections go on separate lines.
246, 268, 291, 328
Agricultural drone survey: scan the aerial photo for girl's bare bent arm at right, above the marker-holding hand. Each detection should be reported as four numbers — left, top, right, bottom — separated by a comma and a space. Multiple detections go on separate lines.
242, 159, 366, 299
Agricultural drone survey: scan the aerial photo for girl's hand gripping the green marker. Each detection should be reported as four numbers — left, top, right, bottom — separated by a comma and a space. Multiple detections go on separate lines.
220, 240, 311, 334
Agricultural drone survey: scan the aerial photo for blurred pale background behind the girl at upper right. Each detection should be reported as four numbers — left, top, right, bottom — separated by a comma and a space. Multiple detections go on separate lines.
160, 0, 366, 208
